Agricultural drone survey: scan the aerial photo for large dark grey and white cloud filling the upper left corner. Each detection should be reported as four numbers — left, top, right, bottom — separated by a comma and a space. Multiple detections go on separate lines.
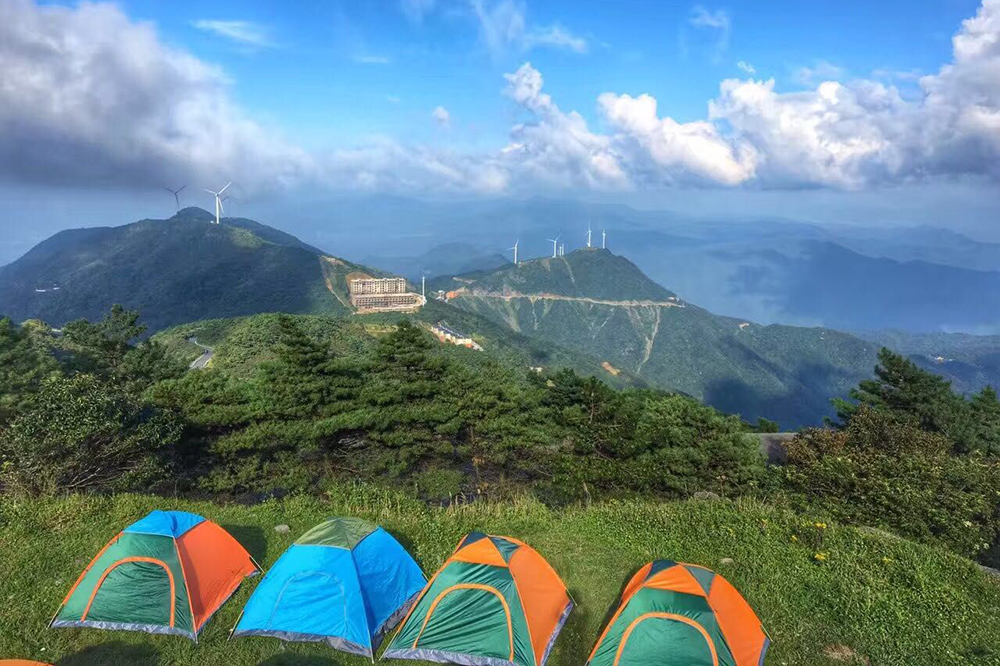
0, 0, 311, 187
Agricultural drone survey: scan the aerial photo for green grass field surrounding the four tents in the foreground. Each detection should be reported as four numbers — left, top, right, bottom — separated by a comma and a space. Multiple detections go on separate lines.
0, 485, 1000, 666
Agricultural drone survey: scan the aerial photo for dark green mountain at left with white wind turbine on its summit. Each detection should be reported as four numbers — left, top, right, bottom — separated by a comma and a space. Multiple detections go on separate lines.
0, 208, 377, 331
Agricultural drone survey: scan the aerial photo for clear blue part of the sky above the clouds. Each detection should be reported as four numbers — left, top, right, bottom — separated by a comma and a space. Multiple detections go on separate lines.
105, 0, 979, 148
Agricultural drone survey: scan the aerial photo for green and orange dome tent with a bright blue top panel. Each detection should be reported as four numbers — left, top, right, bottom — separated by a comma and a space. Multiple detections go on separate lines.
51, 511, 260, 640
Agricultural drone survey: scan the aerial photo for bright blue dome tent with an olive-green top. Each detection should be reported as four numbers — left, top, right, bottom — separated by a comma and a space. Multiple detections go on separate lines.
233, 518, 426, 657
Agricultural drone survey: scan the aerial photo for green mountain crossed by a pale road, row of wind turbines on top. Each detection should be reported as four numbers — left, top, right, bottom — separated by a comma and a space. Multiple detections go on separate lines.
429, 249, 878, 427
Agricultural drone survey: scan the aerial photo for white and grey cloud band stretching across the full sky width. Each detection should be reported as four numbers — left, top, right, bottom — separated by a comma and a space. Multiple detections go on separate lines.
0, 0, 1000, 193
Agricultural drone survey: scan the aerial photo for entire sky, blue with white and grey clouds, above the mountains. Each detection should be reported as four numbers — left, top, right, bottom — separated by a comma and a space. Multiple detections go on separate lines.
0, 0, 1000, 263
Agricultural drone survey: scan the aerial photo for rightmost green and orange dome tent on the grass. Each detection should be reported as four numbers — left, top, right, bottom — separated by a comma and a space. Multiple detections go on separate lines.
587, 560, 770, 666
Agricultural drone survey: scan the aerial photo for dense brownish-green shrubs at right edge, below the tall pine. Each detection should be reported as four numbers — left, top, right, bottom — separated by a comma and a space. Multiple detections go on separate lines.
779, 405, 1000, 556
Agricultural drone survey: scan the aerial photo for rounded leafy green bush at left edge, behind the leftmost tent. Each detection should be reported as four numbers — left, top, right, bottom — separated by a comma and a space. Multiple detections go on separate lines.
0, 374, 181, 494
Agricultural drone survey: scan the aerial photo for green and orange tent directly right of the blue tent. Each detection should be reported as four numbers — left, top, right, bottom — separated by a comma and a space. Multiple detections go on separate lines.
383, 532, 573, 666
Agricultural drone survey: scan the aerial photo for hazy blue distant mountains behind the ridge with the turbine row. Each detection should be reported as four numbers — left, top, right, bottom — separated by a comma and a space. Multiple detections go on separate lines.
280, 196, 1000, 334
